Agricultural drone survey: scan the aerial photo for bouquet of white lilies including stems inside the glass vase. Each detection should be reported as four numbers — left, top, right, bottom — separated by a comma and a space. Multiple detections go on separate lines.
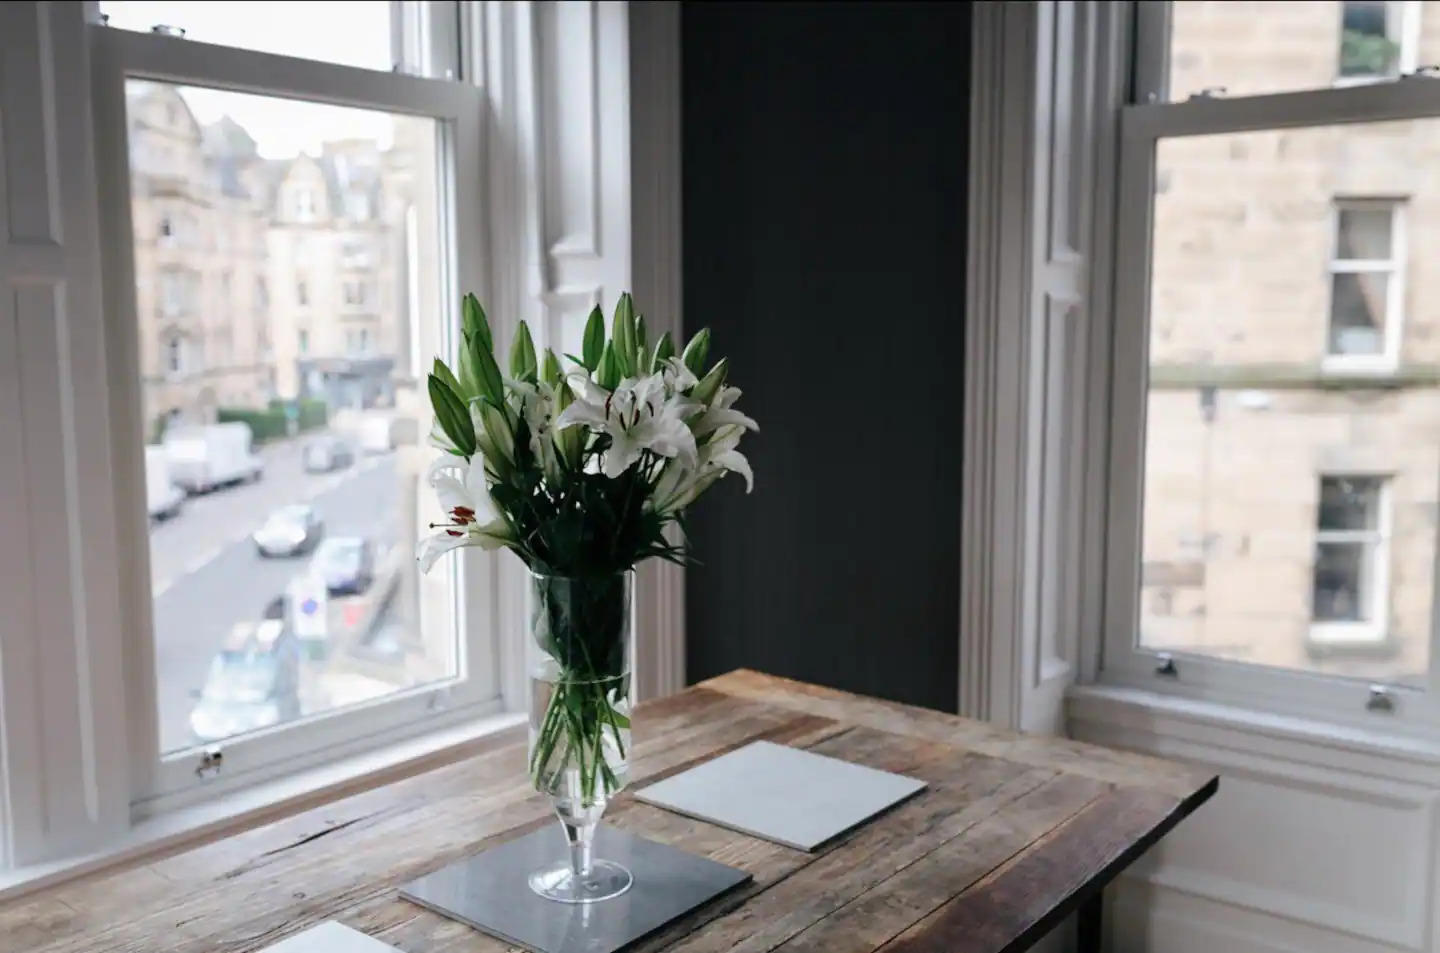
419, 294, 756, 825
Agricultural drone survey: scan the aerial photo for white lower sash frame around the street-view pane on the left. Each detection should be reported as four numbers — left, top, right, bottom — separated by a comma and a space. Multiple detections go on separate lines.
91, 16, 504, 818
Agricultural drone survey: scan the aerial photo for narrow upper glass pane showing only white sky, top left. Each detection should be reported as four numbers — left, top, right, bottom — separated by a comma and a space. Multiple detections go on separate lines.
99, 0, 395, 72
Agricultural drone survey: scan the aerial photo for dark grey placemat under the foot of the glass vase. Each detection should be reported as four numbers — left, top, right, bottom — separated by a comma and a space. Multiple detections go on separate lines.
400, 823, 750, 953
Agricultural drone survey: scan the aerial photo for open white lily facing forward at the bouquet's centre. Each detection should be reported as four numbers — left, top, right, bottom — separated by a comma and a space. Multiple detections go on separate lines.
556, 371, 700, 479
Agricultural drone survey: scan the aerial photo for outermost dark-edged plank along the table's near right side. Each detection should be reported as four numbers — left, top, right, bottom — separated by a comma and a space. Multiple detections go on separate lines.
880, 789, 1203, 953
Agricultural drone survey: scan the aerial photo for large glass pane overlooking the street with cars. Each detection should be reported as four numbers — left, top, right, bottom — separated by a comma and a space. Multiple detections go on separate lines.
127, 81, 459, 751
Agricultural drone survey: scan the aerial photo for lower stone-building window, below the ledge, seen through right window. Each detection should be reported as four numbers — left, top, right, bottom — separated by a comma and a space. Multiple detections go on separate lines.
1310, 475, 1388, 643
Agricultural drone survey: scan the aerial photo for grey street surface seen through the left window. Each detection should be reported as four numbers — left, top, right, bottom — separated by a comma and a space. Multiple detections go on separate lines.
150, 442, 406, 751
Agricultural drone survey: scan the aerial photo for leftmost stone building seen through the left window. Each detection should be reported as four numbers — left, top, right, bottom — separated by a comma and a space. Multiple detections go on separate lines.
127, 81, 275, 426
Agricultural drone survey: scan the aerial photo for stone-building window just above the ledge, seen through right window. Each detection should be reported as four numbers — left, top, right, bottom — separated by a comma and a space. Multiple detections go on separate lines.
1325, 200, 1404, 370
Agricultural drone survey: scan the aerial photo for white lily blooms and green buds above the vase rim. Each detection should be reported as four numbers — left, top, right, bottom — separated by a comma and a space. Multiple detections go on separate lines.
419, 294, 757, 576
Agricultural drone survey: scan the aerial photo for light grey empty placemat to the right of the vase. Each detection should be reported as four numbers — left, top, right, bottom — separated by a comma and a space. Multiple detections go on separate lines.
635, 741, 924, 851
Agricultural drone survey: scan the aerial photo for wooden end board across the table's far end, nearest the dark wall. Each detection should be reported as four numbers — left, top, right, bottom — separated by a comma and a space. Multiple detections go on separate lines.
701, 669, 1212, 796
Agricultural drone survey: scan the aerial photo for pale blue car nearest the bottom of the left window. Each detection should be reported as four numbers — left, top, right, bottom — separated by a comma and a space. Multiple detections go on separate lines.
190, 619, 300, 743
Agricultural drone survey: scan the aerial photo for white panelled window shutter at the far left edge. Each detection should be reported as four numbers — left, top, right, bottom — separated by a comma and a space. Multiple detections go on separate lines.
0, 0, 128, 864
